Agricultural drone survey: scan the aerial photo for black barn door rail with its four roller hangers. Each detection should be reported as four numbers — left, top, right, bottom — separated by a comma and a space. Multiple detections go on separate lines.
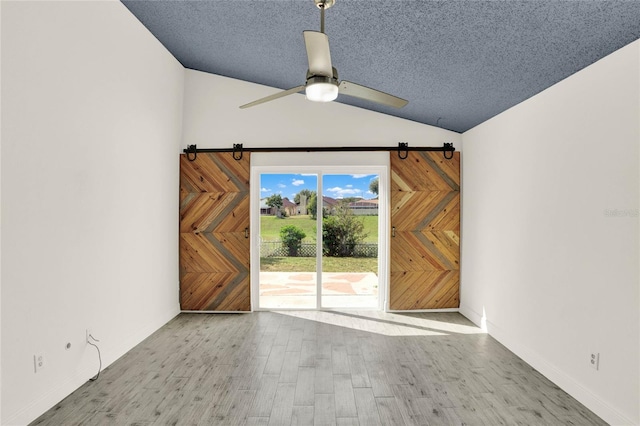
183, 142, 456, 161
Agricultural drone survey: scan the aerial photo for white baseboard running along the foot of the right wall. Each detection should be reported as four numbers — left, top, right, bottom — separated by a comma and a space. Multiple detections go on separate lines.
460, 304, 635, 425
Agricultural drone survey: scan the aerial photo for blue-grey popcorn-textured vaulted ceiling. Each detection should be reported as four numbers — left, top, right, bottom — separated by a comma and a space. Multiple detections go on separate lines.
123, 0, 640, 132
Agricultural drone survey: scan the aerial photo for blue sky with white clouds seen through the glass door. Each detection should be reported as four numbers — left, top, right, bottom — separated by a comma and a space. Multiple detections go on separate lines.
260, 173, 378, 201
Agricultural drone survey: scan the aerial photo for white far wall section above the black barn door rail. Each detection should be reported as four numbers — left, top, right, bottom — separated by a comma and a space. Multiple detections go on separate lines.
182, 70, 462, 150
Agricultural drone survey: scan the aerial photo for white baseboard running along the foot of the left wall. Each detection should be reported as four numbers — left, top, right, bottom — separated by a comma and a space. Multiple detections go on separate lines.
3, 308, 179, 426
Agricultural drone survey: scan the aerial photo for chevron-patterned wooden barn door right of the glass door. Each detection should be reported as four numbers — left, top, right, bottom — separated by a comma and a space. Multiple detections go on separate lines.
389, 152, 460, 310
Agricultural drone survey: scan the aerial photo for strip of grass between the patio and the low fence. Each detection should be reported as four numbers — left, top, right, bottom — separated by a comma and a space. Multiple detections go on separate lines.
260, 257, 378, 274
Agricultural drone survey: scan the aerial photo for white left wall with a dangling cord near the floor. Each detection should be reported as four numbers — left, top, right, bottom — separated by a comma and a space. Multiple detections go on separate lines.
1, 1, 184, 424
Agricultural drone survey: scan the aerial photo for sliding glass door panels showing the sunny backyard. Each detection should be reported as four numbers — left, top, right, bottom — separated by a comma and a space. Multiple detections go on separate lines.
252, 168, 381, 309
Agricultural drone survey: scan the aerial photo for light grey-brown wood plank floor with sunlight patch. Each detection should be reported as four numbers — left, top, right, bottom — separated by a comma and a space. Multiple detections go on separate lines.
32, 311, 606, 426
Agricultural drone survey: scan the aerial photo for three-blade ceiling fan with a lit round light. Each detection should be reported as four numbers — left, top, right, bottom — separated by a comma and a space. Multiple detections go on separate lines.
240, 0, 409, 109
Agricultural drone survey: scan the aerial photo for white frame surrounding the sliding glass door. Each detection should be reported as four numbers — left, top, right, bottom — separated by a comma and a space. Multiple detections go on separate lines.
249, 152, 390, 311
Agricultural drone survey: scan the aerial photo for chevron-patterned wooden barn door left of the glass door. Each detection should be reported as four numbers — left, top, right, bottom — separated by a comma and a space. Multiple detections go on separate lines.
180, 152, 251, 311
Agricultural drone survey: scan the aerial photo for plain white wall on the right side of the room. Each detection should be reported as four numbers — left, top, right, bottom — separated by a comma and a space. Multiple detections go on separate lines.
461, 41, 640, 424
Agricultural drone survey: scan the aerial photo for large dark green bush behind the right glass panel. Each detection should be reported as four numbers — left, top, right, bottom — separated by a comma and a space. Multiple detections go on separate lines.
322, 204, 367, 257
